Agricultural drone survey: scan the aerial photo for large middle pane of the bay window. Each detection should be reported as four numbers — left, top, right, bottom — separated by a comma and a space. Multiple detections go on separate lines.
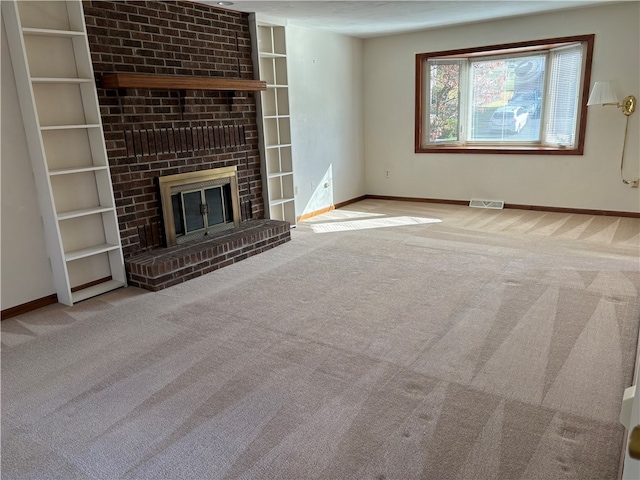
469, 55, 545, 142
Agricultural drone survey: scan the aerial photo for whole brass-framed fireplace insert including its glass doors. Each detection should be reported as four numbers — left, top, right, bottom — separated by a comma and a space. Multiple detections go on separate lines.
159, 167, 240, 246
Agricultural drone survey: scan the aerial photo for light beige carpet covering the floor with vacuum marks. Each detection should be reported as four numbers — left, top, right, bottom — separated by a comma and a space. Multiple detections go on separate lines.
2, 200, 640, 480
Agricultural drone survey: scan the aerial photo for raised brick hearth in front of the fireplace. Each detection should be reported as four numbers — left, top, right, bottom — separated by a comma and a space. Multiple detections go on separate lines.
126, 220, 291, 291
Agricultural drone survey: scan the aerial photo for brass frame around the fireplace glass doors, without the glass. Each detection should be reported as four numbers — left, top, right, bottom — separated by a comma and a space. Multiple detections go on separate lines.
158, 166, 240, 247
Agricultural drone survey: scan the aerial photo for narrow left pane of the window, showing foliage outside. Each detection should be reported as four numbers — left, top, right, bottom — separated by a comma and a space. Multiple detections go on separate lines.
428, 62, 460, 142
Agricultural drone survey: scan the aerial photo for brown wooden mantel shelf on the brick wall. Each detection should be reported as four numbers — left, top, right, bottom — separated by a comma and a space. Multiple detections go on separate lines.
101, 73, 267, 92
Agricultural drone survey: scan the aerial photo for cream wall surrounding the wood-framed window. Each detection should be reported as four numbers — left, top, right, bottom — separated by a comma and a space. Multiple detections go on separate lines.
364, 2, 640, 212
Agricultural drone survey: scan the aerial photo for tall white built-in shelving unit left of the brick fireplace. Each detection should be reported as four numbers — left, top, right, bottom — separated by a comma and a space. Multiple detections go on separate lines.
1, 0, 126, 305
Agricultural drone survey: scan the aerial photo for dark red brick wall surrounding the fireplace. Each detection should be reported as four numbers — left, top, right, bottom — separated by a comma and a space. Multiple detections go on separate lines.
83, 0, 264, 257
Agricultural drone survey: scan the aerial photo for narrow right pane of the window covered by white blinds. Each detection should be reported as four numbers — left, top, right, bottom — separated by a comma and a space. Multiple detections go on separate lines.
546, 46, 582, 147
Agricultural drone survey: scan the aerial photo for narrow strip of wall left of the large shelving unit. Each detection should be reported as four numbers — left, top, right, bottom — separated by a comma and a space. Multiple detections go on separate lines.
0, 14, 55, 310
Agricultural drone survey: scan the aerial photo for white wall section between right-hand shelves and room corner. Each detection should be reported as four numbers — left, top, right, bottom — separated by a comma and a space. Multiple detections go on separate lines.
286, 25, 366, 216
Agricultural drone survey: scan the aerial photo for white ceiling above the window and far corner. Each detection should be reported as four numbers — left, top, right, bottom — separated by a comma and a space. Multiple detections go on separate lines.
200, 0, 618, 38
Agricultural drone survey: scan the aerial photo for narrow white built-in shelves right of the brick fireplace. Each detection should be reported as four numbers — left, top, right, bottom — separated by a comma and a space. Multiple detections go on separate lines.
253, 19, 296, 227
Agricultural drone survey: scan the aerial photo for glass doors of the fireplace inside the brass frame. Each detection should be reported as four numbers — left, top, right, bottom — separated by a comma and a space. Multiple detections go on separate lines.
171, 184, 233, 237
